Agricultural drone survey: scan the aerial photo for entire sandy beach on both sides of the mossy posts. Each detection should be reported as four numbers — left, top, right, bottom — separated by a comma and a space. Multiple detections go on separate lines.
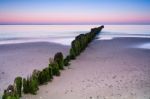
0, 38, 150, 99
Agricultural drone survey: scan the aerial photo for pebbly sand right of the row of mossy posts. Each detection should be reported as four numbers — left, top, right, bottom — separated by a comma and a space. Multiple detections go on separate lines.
17, 38, 150, 99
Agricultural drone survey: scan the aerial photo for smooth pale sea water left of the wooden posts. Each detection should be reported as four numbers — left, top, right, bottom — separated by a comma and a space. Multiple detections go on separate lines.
0, 25, 96, 45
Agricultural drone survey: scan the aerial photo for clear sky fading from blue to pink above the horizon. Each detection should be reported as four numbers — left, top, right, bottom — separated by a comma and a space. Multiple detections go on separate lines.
0, 0, 150, 24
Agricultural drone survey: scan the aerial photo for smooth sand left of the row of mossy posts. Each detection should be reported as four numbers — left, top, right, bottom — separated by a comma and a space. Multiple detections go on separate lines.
0, 42, 69, 94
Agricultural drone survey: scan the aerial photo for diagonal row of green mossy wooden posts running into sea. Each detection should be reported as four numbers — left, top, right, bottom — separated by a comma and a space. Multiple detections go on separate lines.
2, 26, 104, 99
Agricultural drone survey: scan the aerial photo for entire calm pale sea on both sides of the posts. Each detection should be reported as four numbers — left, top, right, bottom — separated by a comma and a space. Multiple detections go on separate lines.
0, 25, 150, 45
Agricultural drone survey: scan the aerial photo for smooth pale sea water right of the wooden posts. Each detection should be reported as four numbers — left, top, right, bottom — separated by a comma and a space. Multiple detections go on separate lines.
99, 25, 150, 39
